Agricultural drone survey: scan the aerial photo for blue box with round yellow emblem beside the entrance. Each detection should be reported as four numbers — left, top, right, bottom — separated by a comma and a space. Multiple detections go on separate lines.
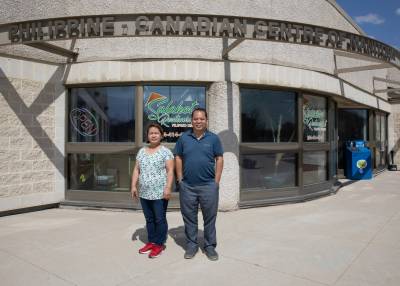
345, 140, 372, 180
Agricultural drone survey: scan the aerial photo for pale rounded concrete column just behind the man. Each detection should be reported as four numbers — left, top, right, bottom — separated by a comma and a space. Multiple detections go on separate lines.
208, 81, 240, 211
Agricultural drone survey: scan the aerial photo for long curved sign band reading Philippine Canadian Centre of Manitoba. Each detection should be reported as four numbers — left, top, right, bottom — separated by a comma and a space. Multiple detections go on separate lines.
0, 14, 400, 65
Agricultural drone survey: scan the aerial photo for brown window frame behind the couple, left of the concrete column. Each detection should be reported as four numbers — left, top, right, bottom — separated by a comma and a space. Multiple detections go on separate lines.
64, 81, 211, 209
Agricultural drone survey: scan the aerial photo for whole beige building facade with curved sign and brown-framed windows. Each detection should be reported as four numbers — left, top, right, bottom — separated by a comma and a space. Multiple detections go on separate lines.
0, 0, 400, 212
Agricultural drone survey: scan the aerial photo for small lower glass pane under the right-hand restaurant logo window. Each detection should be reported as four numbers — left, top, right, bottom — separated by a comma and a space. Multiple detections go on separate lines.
303, 151, 327, 185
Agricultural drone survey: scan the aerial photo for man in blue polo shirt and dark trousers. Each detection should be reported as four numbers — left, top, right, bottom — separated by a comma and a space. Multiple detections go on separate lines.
174, 108, 224, 261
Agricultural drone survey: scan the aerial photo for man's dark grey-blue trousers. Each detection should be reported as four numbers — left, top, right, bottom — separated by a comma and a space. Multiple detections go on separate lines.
179, 182, 219, 249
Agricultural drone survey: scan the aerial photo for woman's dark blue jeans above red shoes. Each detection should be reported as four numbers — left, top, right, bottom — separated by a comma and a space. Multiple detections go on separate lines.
140, 198, 168, 245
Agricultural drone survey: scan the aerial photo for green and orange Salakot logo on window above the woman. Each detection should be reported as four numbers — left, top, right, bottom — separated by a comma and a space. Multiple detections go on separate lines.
145, 92, 200, 127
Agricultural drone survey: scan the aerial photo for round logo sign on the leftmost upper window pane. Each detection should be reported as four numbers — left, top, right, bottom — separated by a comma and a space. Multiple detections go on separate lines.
69, 108, 99, 136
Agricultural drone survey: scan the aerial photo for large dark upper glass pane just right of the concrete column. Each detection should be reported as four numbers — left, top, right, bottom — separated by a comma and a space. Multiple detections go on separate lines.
240, 88, 297, 143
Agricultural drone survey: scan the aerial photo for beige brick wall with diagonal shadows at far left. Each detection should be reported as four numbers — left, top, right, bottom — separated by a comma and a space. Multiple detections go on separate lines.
0, 58, 61, 211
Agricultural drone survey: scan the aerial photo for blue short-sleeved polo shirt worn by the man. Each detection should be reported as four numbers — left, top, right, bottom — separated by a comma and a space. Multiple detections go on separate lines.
174, 130, 224, 186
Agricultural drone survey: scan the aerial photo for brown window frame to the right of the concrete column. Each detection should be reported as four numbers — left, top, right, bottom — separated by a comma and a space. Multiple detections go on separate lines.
239, 85, 337, 204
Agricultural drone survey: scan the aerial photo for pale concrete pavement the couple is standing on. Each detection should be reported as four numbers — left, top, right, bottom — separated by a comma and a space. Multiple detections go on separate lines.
0, 172, 400, 286
